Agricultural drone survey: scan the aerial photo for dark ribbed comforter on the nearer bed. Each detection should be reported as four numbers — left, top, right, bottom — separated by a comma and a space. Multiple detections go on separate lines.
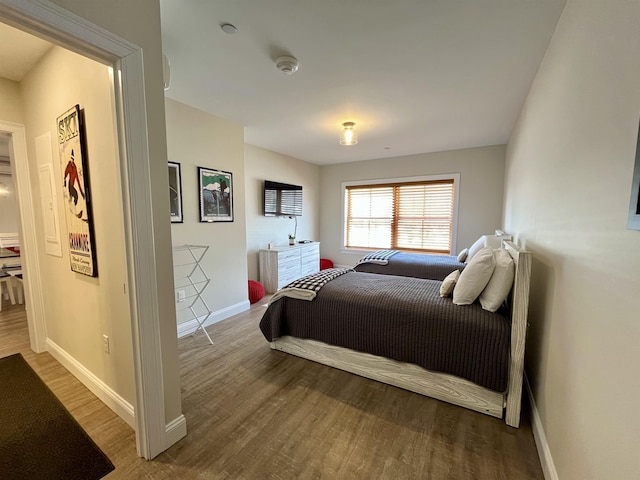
260, 272, 511, 392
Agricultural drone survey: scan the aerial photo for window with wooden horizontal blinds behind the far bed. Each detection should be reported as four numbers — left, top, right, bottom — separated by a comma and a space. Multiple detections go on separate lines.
344, 178, 455, 254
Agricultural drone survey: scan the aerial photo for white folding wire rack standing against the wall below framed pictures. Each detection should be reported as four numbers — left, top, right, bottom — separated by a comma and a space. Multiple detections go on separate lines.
173, 244, 213, 345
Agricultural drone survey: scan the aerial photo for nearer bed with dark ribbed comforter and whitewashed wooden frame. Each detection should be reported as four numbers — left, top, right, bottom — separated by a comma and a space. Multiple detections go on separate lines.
260, 242, 531, 428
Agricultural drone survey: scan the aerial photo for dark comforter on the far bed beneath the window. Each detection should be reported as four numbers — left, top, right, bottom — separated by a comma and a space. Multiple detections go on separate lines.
353, 252, 466, 281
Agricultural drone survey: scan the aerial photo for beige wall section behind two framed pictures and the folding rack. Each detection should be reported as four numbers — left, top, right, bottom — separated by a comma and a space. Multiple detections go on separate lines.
165, 98, 248, 323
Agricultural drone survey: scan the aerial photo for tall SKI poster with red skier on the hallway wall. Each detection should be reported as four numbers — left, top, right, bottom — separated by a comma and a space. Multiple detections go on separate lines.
56, 105, 98, 277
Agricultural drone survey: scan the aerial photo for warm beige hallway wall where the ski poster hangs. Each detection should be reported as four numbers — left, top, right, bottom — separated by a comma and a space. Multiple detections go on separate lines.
21, 47, 135, 405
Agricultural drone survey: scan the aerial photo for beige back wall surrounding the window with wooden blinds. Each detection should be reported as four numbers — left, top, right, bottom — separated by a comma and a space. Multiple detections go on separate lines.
320, 145, 505, 266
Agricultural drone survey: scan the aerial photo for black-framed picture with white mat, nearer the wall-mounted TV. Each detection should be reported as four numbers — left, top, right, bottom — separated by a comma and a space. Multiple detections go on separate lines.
198, 167, 233, 222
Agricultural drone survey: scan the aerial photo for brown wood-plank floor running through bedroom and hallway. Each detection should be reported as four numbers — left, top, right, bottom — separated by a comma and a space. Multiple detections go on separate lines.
0, 299, 543, 480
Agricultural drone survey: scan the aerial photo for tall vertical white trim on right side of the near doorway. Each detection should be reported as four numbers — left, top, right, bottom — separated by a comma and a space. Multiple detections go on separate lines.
116, 49, 171, 459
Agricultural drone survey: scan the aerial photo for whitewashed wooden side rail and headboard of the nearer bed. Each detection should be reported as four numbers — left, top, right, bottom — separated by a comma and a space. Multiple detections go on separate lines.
271, 240, 531, 428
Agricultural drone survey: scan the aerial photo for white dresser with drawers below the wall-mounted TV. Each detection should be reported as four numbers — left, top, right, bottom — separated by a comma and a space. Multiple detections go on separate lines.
260, 242, 320, 293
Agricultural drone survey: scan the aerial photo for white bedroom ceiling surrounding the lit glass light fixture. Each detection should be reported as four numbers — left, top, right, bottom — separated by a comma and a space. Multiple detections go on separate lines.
160, 0, 565, 165
